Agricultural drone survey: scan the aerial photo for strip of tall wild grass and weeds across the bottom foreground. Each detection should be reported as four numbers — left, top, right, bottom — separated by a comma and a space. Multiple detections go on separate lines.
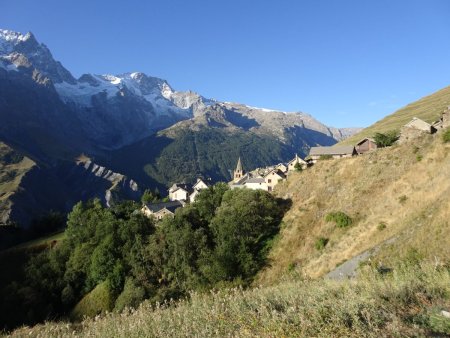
12, 265, 450, 338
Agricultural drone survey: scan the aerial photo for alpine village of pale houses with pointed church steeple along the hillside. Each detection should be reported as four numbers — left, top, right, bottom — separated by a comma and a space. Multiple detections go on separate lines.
141, 106, 450, 221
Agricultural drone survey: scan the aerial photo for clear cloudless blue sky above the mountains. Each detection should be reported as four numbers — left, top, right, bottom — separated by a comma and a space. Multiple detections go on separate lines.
0, 0, 450, 127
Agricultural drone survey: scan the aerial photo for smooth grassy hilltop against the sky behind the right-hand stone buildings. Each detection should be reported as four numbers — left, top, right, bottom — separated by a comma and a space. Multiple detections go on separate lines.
339, 86, 450, 145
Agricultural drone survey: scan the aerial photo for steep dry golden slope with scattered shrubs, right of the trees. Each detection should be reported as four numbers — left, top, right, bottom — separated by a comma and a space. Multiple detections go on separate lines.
259, 134, 450, 284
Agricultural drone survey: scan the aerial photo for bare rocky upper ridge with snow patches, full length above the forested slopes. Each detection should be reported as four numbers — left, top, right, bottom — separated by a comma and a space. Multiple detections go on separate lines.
0, 30, 358, 149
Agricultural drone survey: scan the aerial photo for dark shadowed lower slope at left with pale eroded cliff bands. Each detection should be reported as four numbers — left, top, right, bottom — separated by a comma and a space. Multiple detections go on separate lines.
0, 156, 141, 227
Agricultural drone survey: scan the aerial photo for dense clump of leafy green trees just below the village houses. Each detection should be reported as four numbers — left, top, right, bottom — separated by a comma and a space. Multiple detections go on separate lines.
0, 183, 286, 328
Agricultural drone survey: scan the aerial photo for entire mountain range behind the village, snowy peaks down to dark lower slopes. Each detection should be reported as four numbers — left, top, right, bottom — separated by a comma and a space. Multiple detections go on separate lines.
0, 30, 358, 227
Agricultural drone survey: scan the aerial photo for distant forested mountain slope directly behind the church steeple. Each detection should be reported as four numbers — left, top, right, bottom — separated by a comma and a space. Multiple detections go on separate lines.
104, 128, 298, 191
